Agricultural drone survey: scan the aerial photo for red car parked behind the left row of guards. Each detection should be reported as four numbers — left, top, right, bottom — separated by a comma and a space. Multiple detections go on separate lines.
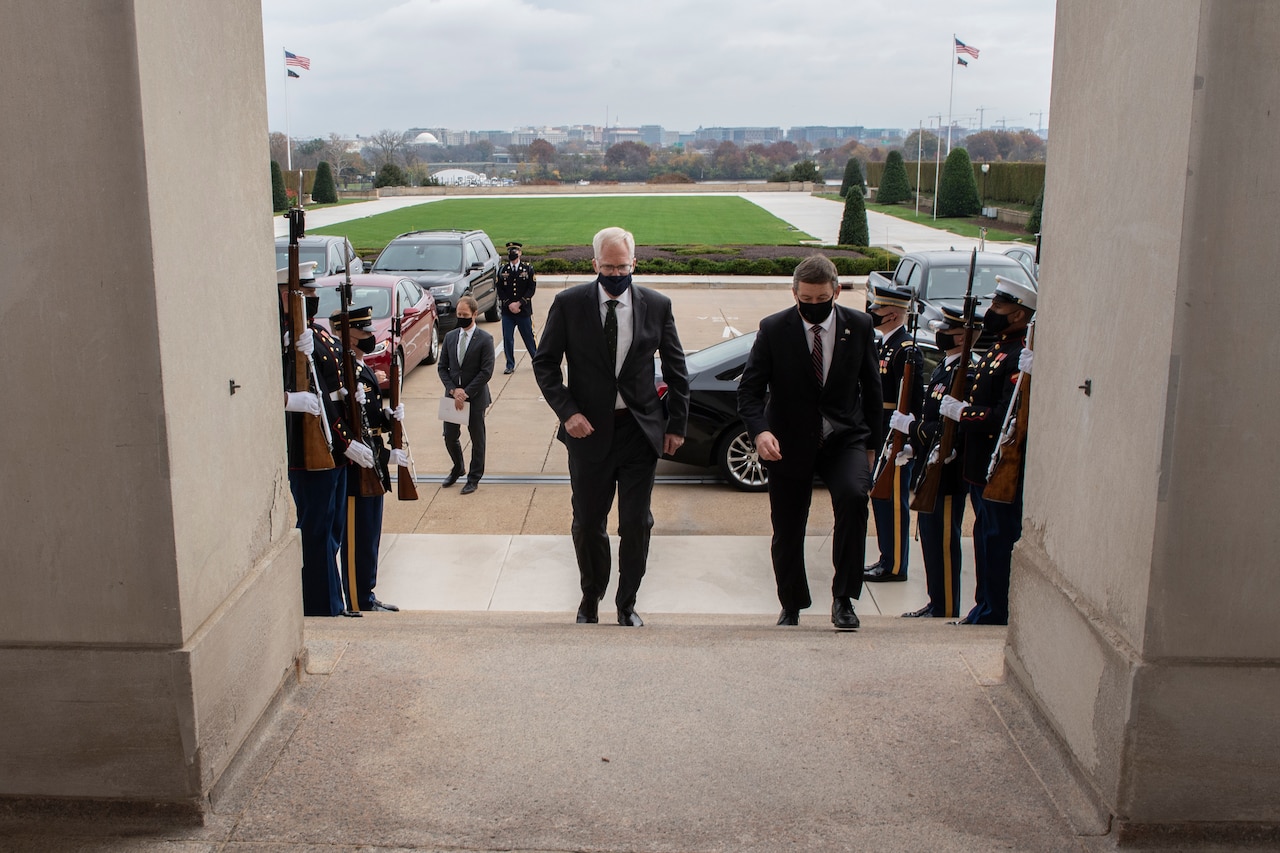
316, 275, 440, 389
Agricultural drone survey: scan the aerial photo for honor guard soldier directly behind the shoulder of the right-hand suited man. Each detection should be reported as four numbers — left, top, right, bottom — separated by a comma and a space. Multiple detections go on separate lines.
864, 284, 924, 581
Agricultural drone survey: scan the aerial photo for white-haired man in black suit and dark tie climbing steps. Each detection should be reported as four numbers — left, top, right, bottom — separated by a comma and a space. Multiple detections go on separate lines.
534, 228, 689, 626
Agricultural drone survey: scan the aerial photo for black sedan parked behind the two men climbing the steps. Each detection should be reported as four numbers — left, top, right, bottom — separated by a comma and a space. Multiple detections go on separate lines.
654, 329, 938, 492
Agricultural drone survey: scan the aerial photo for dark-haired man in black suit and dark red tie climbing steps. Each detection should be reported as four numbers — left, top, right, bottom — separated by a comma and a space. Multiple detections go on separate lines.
737, 255, 883, 630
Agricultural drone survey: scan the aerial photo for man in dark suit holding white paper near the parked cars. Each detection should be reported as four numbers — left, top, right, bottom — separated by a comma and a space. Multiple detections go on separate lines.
435, 296, 494, 494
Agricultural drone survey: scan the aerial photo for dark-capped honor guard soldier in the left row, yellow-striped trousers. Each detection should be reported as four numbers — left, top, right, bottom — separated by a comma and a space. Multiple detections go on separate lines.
329, 305, 408, 612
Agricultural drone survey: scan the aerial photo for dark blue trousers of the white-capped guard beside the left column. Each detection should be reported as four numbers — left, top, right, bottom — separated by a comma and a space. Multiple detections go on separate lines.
289, 465, 347, 616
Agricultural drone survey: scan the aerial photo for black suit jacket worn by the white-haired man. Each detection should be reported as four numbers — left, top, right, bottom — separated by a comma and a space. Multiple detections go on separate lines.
534, 282, 689, 461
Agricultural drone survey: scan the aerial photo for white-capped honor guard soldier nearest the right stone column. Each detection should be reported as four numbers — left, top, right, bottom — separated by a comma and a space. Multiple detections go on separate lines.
940, 275, 1037, 625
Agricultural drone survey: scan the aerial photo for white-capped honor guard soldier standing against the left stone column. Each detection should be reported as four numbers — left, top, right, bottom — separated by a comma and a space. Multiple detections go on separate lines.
276, 261, 374, 616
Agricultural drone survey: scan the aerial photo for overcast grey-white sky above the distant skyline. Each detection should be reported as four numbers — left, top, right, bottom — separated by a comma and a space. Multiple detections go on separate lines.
262, 0, 1055, 138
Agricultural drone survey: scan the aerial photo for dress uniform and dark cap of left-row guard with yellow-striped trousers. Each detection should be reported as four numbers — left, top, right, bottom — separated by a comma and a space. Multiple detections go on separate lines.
329, 305, 399, 611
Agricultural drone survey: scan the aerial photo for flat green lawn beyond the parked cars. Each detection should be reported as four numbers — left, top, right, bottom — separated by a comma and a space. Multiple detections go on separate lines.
311, 196, 813, 252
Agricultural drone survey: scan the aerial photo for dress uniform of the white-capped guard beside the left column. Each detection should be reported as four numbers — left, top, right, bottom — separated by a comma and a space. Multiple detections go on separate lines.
278, 264, 355, 616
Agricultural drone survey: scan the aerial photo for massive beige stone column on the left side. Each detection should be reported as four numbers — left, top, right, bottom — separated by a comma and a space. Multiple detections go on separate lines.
0, 0, 302, 813
